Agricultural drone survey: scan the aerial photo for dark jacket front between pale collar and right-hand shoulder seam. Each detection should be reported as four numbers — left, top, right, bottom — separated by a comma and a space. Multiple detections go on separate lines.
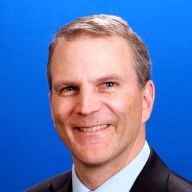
130, 149, 169, 192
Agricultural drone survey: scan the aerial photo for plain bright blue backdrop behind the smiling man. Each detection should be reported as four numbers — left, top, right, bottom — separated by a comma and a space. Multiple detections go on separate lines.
0, 0, 192, 192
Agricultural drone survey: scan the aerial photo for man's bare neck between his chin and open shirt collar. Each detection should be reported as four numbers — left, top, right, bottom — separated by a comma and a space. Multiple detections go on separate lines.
74, 128, 145, 190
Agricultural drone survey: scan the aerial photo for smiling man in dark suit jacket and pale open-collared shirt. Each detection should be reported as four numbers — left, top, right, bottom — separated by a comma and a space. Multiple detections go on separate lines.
27, 15, 192, 192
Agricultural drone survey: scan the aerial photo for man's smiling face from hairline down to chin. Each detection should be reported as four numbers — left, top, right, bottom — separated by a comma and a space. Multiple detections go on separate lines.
50, 37, 154, 168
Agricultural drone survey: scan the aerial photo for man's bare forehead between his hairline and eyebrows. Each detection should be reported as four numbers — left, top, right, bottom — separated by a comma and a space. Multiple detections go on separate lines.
51, 36, 134, 82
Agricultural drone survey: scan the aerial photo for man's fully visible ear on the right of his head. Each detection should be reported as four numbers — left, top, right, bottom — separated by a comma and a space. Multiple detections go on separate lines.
142, 80, 155, 123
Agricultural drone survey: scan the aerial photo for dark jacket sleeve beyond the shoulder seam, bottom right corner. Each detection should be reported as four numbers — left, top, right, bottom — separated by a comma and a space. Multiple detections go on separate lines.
168, 171, 192, 192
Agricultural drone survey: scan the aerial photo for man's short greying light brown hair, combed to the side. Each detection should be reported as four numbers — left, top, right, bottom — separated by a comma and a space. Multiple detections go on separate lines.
47, 14, 151, 91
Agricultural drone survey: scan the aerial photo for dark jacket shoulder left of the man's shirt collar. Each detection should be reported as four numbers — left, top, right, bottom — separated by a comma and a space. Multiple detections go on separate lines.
25, 171, 72, 192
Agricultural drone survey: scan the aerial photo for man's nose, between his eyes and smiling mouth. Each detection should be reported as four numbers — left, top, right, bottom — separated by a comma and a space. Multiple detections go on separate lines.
75, 89, 102, 115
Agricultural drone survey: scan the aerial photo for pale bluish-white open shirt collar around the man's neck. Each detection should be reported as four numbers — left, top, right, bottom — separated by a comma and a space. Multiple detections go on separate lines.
72, 141, 150, 192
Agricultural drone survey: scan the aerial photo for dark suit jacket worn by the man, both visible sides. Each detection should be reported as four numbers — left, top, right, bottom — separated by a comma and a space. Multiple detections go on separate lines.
26, 150, 192, 192
